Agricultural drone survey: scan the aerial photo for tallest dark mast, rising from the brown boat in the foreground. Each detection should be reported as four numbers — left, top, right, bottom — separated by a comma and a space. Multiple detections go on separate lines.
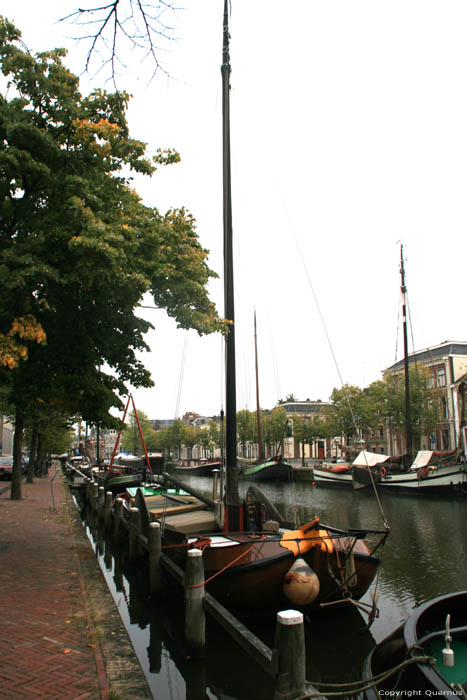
221, 0, 239, 516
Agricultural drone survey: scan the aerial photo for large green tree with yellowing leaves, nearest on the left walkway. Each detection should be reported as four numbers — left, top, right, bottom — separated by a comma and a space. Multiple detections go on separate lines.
0, 18, 224, 498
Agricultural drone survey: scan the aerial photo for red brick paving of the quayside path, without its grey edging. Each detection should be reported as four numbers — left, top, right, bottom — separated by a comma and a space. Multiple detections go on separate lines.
0, 467, 108, 700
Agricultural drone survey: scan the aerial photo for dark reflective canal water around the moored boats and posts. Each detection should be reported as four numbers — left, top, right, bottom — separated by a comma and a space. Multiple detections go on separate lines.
75, 477, 467, 700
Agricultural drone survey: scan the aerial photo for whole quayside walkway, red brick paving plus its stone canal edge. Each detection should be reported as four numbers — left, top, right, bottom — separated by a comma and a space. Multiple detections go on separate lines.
0, 466, 152, 700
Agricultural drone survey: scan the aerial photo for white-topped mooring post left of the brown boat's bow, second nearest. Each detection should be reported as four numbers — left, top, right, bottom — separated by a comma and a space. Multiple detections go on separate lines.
185, 549, 206, 659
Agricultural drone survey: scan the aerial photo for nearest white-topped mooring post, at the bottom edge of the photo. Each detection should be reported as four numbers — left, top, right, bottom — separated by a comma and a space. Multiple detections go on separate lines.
274, 610, 306, 700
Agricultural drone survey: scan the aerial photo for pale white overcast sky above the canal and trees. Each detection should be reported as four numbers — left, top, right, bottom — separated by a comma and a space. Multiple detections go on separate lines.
6, 0, 467, 418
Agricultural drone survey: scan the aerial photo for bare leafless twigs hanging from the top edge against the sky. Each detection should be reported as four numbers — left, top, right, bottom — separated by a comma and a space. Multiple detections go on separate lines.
60, 0, 180, 87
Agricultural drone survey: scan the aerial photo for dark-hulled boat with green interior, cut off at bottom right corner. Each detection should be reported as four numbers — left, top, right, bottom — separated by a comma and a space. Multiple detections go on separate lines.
362, 591, 467, 700
